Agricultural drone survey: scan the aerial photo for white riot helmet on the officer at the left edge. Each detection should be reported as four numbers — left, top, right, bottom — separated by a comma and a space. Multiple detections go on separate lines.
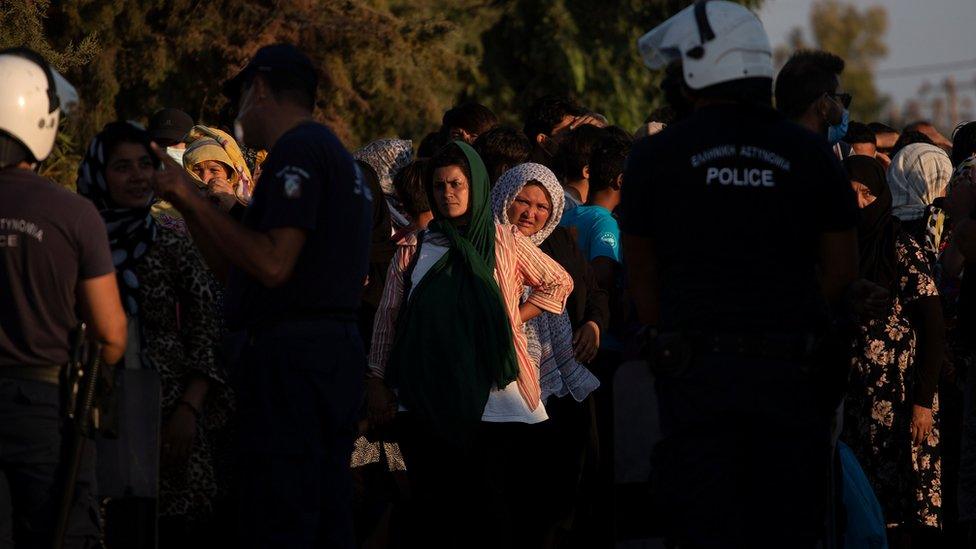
0, 48, 78, 162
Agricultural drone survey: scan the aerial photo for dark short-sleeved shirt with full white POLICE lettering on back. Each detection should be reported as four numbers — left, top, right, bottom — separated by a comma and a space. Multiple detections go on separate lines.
618, 105, 857, 332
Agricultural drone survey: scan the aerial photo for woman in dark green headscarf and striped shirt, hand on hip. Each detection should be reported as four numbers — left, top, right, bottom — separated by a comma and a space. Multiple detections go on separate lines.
368, 142, 573, 546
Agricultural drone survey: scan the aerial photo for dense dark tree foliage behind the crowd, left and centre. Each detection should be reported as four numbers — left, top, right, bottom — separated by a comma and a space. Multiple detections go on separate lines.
0, 0, 760, 186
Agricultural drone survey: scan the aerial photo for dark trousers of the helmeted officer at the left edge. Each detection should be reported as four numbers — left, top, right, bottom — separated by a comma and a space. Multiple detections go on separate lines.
0, 378, 99, 549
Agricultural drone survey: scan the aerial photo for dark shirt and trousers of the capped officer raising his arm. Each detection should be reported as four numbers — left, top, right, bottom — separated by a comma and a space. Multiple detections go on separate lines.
225, 122, 372, 547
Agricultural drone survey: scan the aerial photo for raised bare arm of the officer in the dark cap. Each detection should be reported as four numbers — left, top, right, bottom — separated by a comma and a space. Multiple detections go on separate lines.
153, 144, 306, 288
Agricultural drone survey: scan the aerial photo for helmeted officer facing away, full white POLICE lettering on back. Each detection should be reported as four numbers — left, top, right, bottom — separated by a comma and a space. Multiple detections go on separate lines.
620, 0, 858, 548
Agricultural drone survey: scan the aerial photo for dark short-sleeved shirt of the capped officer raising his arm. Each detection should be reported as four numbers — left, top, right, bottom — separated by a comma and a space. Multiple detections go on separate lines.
225, 122, 373, 329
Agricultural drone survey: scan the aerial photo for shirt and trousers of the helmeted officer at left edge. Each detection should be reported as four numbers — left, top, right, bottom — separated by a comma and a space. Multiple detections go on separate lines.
0, 168, 109, 547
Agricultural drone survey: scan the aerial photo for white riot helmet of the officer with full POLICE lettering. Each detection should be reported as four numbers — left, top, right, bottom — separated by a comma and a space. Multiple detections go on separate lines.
637, 0, 773, 90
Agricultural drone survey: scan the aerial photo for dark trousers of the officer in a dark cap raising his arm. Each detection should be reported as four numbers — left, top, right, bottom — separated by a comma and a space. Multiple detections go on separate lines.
235, 320, 366, 549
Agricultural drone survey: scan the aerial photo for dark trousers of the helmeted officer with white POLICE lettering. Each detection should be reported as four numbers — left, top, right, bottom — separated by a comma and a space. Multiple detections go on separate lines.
653, 353, 831, 549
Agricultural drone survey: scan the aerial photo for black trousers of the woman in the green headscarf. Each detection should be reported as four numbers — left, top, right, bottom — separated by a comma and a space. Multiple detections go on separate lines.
398, 412, 551, 549
